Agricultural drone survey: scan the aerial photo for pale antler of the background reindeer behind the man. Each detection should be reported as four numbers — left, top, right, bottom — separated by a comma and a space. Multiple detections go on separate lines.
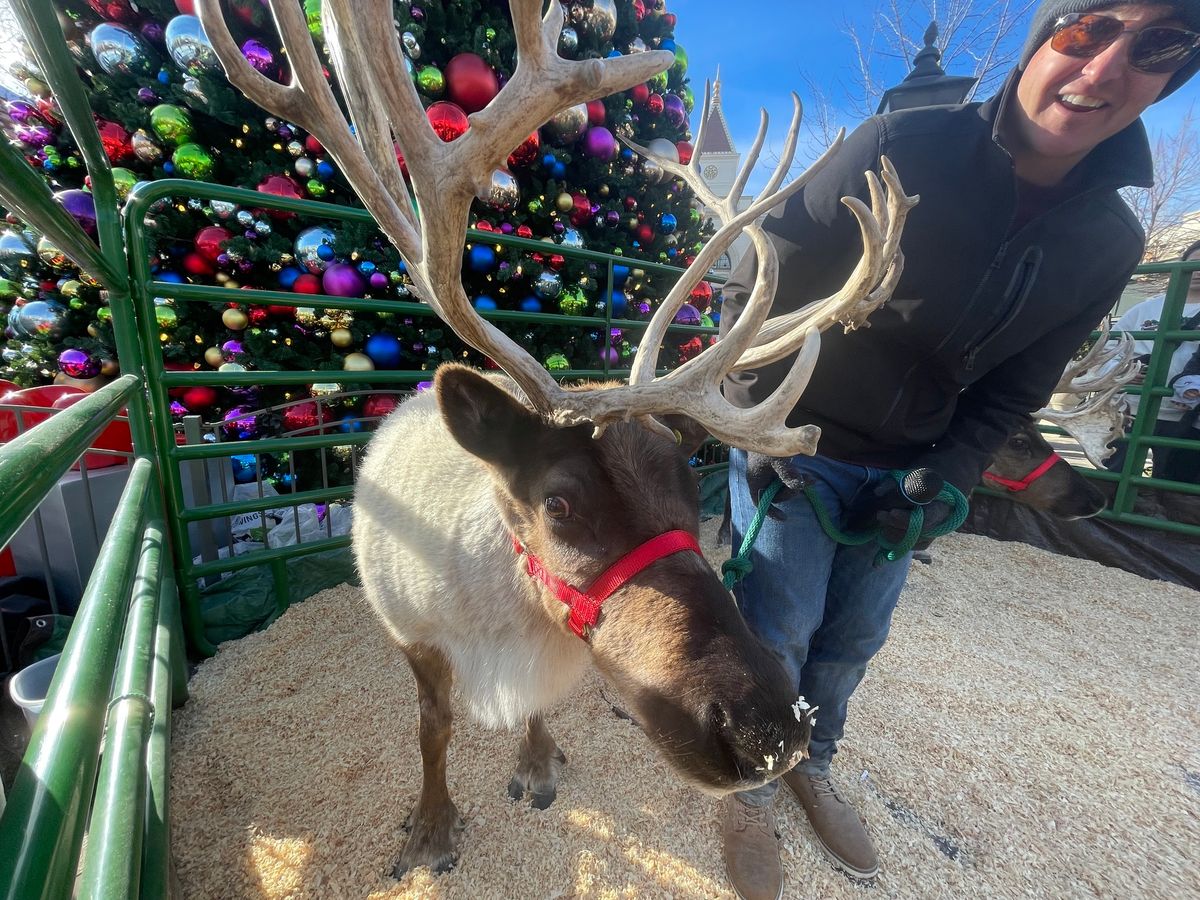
1033, 324, 1141, 467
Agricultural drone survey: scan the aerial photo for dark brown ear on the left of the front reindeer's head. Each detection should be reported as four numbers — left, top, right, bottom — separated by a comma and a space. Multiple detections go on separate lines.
433, 365, 546, 466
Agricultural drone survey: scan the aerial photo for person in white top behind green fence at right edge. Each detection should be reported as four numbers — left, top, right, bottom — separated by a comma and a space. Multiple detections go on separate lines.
1105, 241, 1200, 482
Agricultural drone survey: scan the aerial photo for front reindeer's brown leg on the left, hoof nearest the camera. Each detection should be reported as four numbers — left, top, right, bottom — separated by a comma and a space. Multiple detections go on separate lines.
392, 647, 463, 878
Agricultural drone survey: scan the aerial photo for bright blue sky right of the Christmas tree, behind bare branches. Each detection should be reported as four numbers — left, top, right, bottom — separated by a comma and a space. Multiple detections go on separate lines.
667, 0, 1200, 192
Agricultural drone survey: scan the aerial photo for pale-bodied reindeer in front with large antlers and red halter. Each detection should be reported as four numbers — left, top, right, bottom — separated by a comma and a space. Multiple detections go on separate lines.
197, 0, 917, 876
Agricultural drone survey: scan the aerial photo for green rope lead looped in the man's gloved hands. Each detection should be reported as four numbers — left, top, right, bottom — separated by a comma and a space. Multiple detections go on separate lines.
721, 469, 968, 590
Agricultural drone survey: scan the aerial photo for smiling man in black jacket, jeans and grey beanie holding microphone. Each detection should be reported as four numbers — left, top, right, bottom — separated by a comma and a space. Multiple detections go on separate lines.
721, 0, 1200, 900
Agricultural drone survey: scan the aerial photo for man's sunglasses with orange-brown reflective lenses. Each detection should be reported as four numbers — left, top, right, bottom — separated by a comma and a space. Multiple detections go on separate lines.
1050, 12, 1200, 74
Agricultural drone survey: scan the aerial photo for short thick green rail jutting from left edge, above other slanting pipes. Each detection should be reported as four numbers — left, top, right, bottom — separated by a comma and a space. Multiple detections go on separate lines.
0, 374, 138, 547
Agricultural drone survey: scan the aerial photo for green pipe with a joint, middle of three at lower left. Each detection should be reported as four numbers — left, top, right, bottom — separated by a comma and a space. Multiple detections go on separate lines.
77, 520, 170, 900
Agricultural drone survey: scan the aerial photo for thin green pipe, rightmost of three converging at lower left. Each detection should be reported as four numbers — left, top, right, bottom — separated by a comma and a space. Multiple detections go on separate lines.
138, 570, 177, 900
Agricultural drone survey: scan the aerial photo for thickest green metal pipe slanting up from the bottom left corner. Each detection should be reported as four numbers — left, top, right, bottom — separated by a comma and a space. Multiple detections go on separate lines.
0, 458, 154, 900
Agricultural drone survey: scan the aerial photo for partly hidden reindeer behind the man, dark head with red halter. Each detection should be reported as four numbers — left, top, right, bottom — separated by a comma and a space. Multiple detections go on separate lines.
983, 328, 1141, 520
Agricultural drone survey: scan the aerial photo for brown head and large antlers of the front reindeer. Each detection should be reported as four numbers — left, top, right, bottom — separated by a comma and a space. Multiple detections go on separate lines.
197, 0, 916, 792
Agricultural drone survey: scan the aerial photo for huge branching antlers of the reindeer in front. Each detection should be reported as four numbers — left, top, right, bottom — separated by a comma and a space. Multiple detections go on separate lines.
197, 0, 916, 456
